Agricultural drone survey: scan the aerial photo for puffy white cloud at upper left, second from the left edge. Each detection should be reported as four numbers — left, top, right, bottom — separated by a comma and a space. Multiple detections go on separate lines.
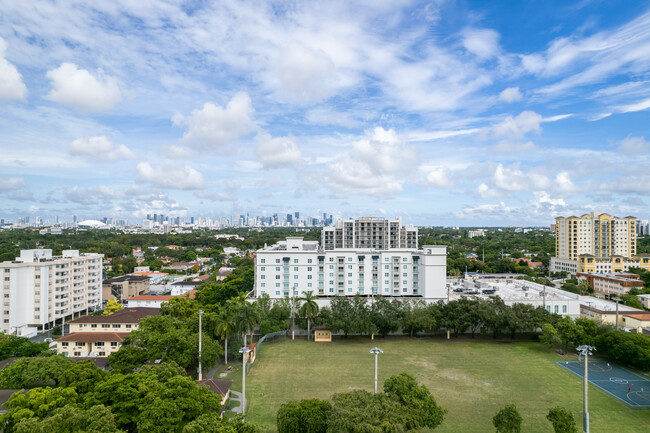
45, 63, 122, 111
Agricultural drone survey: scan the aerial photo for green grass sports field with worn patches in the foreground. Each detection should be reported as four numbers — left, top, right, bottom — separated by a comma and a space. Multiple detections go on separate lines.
239, 339, 650, 433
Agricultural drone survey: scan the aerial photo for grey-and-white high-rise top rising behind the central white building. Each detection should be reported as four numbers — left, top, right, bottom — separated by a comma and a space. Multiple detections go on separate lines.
321, 217, 418, 250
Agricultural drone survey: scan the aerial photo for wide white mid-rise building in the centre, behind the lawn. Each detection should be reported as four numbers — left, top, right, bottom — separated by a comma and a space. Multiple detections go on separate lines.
254, 237, 447, 300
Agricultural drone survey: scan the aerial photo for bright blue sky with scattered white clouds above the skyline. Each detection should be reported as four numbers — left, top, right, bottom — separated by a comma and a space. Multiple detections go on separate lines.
0, 0, 650, 226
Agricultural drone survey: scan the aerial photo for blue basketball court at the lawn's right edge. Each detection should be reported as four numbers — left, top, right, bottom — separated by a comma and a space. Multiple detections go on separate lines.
557, 361, 650, 409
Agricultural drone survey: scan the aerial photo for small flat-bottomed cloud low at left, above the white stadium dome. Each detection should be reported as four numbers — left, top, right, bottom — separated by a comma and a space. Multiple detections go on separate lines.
135, 162, 203, 190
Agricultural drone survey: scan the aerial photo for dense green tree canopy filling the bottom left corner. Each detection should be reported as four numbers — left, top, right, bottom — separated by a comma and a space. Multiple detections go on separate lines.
0, 355, 259, 433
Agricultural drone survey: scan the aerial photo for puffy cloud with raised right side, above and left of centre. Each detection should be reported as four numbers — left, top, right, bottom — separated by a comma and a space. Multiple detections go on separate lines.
172, 93, 256, 149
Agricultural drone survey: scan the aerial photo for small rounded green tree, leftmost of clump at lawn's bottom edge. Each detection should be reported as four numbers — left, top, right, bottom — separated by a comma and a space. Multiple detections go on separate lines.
277, 399, 332, 433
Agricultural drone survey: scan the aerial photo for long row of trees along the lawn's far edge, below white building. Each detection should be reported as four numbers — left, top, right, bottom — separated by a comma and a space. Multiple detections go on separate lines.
313, 295, 559, 338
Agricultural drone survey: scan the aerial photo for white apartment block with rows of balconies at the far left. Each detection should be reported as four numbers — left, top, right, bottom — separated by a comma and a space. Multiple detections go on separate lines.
0, 250, 104, 336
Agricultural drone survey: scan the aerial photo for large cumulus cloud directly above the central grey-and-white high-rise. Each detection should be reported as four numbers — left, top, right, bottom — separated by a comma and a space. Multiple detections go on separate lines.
324, 127, 419, 197
